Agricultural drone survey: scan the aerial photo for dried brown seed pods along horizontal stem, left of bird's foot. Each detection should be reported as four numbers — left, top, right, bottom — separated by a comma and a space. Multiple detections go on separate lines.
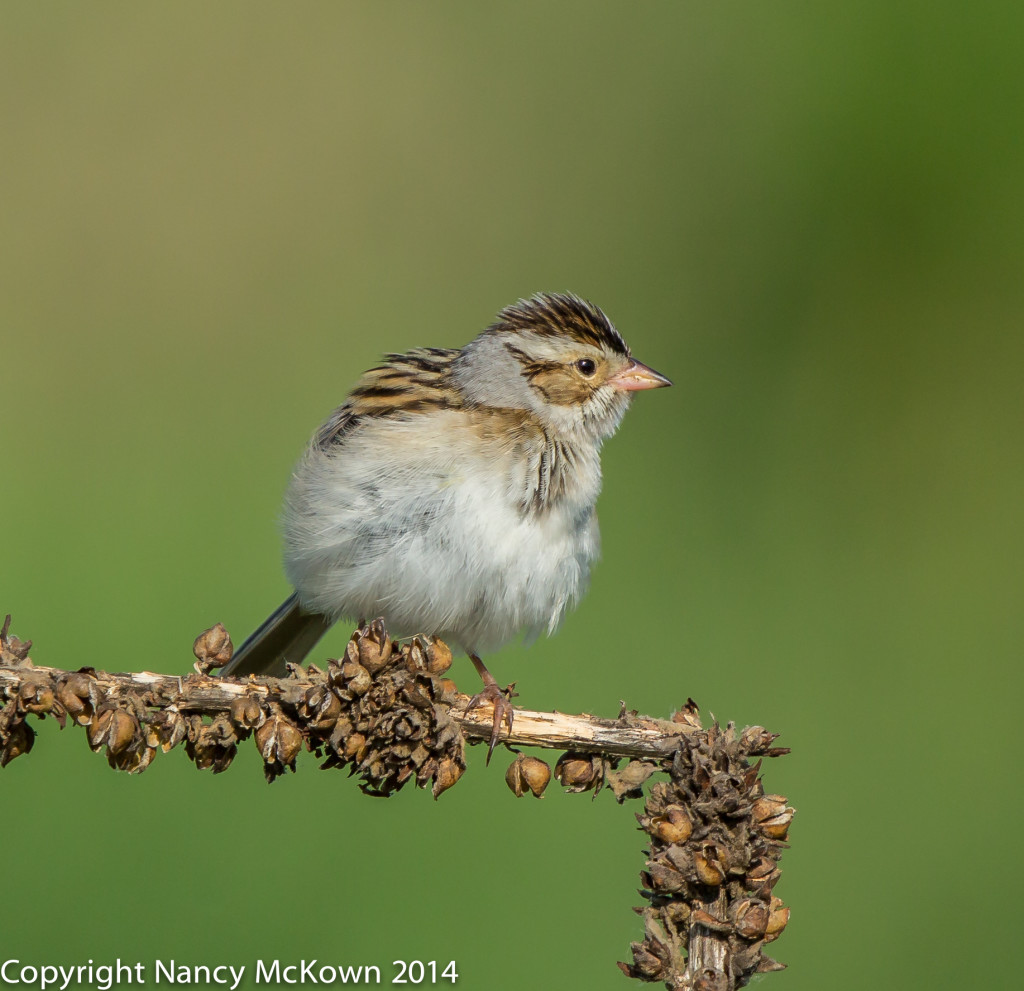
0, 618, 466, 798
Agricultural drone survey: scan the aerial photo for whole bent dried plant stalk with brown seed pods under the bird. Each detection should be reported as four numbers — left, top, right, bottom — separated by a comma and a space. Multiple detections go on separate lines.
0, 616, 794, 991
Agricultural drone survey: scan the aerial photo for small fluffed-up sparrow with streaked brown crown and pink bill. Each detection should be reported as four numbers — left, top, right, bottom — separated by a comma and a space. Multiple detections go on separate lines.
221, 293, 672, 761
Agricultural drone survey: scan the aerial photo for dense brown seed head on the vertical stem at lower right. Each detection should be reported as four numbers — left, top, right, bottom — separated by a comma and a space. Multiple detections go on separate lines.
620, 708, 794, 988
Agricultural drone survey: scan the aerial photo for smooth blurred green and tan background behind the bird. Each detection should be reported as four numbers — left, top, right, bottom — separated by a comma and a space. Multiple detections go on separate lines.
0, 0, 1024, 989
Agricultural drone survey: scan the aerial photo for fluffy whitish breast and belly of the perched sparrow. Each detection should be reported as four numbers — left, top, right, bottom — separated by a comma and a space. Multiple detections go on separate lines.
284, 410, 600, 652
